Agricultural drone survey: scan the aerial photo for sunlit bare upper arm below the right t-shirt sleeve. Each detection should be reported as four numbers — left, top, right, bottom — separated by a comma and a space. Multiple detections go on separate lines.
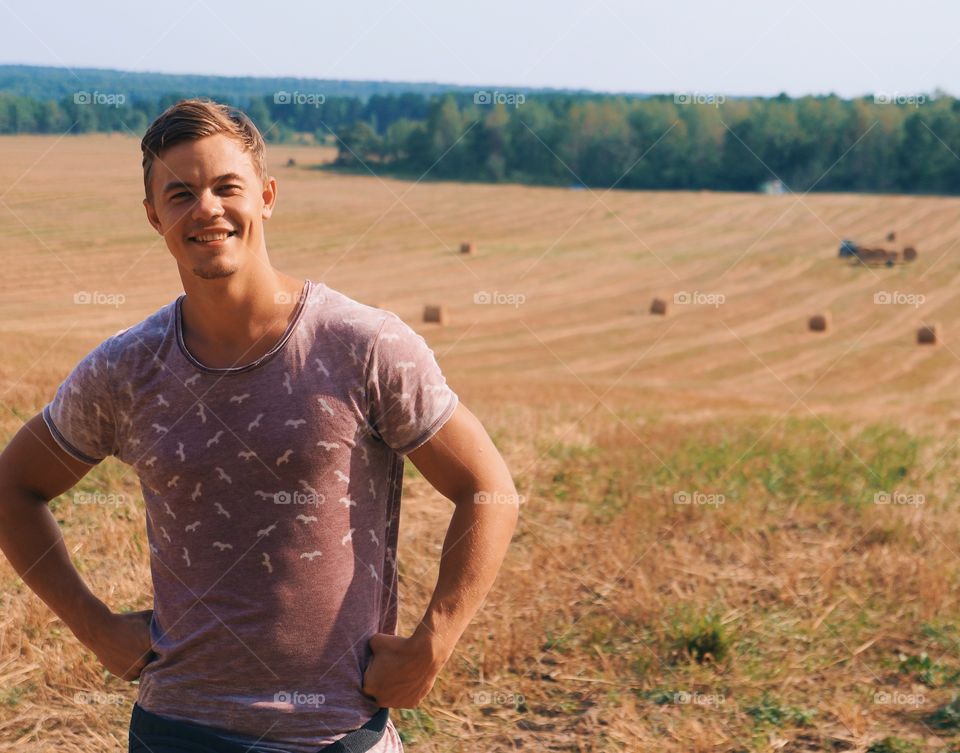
407, 402, 512, 502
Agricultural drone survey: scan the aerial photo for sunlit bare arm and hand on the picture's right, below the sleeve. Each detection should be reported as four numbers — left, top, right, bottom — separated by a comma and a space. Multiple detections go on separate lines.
363, 403, 519, 708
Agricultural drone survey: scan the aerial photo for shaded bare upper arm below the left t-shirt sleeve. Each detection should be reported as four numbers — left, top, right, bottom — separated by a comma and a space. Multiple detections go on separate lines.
0, 413, 93, 504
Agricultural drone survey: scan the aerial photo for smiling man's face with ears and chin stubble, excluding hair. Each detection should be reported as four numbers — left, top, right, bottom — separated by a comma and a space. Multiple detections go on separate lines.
143, 134, 277, 280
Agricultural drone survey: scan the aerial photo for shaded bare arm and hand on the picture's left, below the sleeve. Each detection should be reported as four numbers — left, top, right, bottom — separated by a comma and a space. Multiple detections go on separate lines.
0, 414, 151, 680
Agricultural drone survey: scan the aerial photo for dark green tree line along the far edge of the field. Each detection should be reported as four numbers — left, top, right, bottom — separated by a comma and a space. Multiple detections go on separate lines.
0, 90, 960, 194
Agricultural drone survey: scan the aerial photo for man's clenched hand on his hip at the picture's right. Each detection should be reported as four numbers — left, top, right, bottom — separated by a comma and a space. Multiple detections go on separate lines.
363, 633, 446, 709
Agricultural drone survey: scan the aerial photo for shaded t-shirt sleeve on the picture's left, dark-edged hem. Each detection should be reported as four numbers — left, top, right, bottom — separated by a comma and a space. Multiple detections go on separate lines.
43, 340, 116, 465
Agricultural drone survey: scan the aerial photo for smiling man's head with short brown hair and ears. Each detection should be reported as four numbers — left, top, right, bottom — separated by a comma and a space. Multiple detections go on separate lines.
140, 99, 277, 279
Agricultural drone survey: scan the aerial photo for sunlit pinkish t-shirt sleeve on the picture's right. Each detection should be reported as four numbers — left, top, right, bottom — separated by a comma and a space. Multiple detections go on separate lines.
367, 313, 458, 455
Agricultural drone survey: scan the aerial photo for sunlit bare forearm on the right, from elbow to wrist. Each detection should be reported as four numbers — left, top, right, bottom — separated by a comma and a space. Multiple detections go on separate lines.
413, 485, 518, 663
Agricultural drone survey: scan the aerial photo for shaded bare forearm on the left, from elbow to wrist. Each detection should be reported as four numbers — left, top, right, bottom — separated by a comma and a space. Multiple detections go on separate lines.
0, 490, 110, 643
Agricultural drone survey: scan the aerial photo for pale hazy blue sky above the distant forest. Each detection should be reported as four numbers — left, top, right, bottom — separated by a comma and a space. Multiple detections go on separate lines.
0, 0, 960, 97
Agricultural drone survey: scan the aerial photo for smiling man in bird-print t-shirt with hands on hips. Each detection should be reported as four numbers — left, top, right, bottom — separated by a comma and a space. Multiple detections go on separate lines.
0, 100, 517, 753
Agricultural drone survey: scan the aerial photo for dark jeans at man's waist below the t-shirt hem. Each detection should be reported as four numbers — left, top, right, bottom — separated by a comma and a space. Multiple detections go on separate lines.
128, 703, 389, 753
